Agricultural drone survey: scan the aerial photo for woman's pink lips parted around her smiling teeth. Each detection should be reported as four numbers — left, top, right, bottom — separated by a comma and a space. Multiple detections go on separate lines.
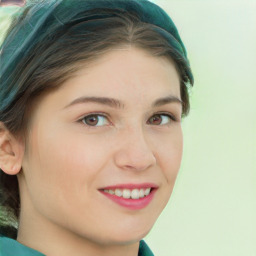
99, 183, 158, 210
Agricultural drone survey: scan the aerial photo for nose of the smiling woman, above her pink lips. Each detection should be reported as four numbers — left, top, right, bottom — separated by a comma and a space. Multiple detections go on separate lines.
114, 126, 156, 171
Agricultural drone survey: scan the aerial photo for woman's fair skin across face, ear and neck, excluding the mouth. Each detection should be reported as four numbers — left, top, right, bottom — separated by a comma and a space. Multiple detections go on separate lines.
0, 47, 183, 256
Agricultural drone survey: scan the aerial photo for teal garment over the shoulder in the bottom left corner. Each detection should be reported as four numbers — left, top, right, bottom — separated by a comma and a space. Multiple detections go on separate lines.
0, 235, 43, 256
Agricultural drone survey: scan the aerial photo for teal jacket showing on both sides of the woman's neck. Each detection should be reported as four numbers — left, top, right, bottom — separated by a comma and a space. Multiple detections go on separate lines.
0, 236, 154, 256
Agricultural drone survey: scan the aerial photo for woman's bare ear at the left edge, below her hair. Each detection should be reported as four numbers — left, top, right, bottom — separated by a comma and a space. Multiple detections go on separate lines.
0, 122, 24, 175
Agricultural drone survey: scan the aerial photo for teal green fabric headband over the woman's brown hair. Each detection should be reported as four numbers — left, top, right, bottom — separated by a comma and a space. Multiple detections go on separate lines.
0, 0, 193, 111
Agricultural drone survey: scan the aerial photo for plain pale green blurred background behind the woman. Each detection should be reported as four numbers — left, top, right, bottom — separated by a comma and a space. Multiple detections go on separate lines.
0, 0, 256, 256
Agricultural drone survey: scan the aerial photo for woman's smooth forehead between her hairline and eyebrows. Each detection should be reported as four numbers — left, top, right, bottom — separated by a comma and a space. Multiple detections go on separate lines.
30, 48, 180, 120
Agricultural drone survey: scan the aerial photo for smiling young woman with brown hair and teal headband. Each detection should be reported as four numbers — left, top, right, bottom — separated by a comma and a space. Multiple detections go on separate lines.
0, 0, 193, 256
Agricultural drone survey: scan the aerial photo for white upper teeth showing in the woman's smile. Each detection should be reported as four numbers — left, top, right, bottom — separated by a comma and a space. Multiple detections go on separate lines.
104, 188, 151, 199
